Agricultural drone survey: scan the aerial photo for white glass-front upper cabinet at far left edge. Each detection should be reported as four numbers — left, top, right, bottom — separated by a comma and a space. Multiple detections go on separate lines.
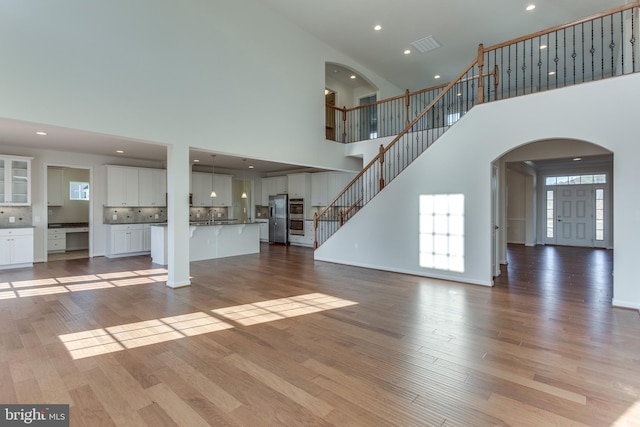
0, 156, 31, 206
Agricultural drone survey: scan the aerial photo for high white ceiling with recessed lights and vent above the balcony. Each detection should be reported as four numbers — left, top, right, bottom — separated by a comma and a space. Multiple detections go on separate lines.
261, 0, 625, 91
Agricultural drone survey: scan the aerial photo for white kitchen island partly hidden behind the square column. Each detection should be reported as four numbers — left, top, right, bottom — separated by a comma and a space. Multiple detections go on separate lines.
151, 222, 260, 265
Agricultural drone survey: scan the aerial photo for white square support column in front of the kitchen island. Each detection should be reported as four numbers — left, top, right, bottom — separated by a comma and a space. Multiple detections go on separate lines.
167, 145, 191, 288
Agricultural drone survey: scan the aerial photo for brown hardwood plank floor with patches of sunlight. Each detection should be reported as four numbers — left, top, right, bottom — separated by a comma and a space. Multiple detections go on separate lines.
0, 245, 640, 427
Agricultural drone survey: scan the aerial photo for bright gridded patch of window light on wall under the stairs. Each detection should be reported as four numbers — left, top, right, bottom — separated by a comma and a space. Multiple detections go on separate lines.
420, 194, 464, 272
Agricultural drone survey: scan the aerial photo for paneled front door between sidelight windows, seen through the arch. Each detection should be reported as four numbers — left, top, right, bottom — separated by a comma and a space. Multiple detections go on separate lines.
556, 185, 595, 247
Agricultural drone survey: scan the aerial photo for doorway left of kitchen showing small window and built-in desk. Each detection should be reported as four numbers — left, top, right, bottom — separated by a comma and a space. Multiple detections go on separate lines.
45, 165, 92, 261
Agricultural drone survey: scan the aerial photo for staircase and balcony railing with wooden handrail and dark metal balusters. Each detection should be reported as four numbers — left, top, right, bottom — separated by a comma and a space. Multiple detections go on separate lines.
314, 1, 640, 248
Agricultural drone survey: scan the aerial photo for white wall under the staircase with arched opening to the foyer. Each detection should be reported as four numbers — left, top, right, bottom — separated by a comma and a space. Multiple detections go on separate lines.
315, 74, 640, 308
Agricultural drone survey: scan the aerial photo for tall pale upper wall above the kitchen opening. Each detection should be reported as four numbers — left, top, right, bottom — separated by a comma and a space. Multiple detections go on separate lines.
0, 0, 401, 174
